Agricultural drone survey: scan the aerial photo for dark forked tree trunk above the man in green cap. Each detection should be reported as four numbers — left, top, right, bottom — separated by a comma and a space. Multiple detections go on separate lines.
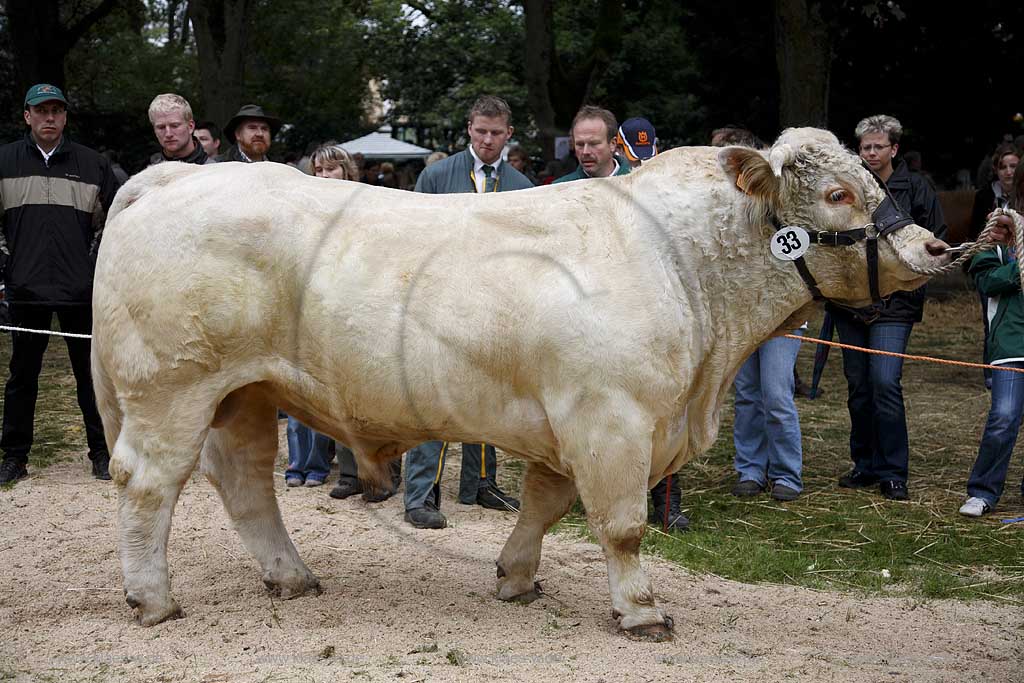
6, 0, 119, 93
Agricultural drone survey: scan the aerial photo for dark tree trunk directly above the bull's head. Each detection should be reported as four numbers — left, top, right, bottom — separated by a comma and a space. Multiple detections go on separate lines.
775, 0, 833, 128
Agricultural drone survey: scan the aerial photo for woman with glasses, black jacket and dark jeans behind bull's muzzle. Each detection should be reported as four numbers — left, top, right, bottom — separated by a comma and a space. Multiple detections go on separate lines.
826, 115, 946, 501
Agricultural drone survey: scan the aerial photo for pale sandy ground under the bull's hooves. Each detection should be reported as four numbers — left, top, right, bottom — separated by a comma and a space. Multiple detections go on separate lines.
0, 444, 1024, 683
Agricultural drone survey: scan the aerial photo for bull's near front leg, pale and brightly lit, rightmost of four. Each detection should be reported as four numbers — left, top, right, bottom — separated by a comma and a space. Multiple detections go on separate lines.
566, 403, 673, 641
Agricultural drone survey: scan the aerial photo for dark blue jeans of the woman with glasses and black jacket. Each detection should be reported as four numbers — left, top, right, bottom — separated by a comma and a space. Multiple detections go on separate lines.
834, 313, 913, 483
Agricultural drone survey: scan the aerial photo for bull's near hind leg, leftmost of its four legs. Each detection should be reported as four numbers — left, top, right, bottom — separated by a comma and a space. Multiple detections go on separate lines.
111, 407, 209, 626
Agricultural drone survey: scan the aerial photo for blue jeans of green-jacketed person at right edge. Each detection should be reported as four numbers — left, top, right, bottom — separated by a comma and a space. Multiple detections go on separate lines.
967, 362, 1024, 508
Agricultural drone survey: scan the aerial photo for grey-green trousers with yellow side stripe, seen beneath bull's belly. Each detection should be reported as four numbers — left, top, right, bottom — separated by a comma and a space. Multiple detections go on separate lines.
406, 441, 498, 510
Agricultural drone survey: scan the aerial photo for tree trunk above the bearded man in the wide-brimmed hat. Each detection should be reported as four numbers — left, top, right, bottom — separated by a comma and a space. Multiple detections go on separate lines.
188, 0, 258, 126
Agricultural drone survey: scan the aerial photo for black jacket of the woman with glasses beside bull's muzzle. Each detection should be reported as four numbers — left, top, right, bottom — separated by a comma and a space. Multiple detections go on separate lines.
825, 162, 946, 323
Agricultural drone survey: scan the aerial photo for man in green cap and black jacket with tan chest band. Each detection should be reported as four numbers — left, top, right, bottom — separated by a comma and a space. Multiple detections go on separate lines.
0, 83, 119, 483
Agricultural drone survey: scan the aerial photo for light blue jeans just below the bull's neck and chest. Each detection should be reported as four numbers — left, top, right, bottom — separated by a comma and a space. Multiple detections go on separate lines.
732, 330, 804, 490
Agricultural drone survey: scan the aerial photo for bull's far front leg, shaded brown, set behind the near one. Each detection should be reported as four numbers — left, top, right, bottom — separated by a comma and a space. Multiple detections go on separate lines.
498, 463, 577, 602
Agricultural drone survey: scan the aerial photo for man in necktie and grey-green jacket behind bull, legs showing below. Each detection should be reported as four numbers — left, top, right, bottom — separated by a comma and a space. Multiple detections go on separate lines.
406, 95, 534, 528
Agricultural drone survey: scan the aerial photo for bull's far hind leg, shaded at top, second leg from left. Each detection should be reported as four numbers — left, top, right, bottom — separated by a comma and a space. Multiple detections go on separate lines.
196, 387, 319, 599
